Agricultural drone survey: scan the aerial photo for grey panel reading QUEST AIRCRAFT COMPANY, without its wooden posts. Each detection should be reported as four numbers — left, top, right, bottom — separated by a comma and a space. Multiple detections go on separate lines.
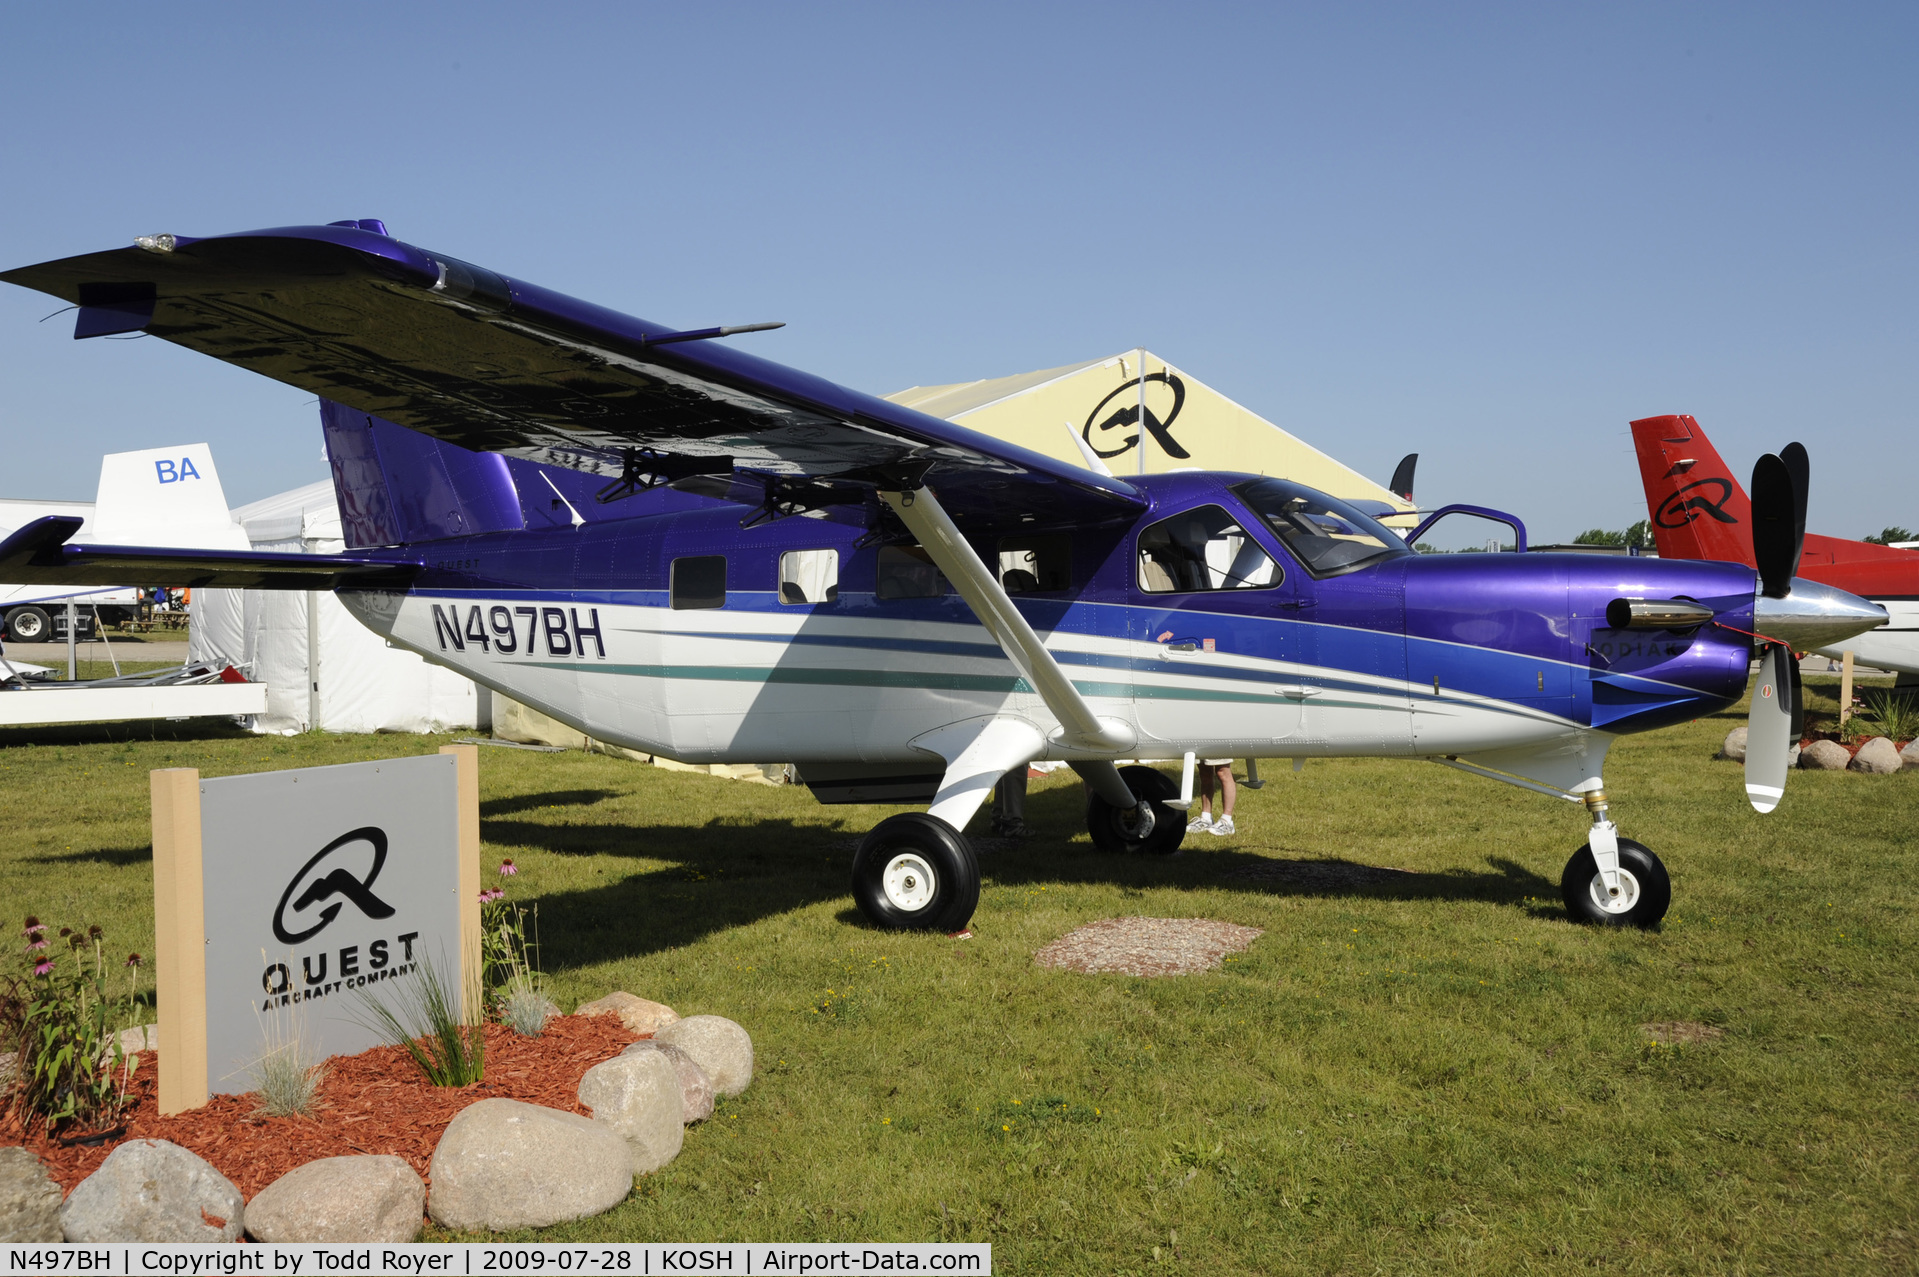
201, 755, 461, 1093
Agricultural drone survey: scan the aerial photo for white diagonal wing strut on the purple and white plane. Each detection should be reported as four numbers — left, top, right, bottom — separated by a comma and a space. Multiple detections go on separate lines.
879, 488, 1138, 752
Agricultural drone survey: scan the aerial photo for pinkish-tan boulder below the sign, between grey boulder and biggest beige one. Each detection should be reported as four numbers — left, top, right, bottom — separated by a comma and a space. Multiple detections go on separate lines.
246, 1154, 426, 1242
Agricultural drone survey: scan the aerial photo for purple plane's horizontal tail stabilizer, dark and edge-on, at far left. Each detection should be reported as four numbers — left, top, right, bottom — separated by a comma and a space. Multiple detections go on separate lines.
0, 515, 418, 590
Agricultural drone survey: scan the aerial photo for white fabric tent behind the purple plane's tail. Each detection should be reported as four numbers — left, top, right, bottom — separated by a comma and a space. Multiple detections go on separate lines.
188, 482, 491, 734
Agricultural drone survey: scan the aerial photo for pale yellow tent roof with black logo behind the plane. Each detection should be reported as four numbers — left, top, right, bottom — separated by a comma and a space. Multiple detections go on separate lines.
887, 349, 1412, 522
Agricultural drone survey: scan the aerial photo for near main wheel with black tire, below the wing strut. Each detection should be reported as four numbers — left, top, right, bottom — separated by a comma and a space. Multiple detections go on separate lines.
852, 812, 979, 931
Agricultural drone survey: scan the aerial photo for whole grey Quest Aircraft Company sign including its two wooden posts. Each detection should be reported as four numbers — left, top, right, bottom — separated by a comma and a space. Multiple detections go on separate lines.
154, 745, 480, 1112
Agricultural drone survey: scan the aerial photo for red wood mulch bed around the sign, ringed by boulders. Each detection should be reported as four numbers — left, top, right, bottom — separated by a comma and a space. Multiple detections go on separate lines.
0, 1016, 639, 1200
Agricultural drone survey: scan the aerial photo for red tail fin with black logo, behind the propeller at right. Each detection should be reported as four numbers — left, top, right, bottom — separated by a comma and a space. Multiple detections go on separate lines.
1633, 417, 1754, 566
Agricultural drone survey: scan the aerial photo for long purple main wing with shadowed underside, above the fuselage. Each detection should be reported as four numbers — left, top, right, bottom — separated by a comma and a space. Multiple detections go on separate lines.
0, 225, 1144, 526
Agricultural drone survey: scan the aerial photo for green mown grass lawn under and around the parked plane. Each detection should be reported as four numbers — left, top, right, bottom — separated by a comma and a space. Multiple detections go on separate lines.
0, 680, 1919, 1273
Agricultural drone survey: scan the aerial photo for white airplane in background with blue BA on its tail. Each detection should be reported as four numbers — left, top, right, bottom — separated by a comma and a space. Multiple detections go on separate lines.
0, 444, 249, 643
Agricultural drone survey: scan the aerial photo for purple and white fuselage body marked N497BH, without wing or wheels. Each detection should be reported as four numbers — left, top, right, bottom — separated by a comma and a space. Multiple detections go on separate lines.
342, 474, 1754, 775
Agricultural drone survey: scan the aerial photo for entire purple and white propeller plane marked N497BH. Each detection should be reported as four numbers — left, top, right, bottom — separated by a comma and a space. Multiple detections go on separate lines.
0, 221, 1884, 931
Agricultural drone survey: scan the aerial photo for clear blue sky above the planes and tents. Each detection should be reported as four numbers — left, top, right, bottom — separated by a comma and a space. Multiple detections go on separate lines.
0, 2, 1919, 540
